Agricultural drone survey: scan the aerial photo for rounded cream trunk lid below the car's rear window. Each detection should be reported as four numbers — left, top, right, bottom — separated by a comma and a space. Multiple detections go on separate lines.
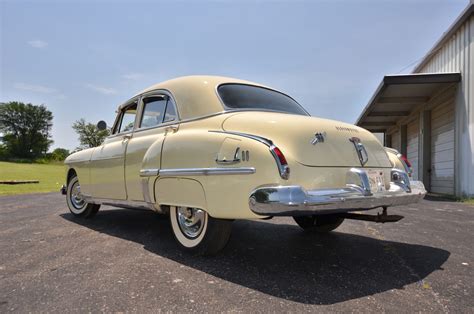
222, 111, 392, 168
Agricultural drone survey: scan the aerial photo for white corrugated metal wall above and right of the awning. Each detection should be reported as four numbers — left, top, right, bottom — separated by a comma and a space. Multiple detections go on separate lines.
417, 14, 474, 196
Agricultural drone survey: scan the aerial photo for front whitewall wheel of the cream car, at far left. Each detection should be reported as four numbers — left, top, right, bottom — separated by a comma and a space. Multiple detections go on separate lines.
66, 175, 100, 218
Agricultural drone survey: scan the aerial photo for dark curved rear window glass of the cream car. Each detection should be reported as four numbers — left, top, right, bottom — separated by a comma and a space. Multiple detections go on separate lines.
217, 84, 308, 116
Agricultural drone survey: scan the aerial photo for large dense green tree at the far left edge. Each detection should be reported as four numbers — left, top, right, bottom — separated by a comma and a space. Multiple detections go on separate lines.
0, 101, 53, 159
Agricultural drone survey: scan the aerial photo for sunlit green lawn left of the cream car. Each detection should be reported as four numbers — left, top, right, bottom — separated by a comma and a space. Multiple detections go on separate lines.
0, 161, 65, 195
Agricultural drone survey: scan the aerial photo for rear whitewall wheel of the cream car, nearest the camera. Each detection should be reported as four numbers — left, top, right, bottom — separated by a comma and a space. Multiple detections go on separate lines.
170, 206, 232, 255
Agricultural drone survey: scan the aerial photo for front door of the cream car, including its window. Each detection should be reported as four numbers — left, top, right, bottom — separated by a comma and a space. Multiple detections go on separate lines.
90, 99, 138, 200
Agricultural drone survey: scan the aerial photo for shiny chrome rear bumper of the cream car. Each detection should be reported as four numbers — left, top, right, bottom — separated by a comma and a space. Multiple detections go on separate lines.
249, 168, 426, 216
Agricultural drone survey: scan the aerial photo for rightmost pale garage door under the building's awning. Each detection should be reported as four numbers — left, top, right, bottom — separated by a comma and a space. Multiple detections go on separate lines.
430, 100, 454, 194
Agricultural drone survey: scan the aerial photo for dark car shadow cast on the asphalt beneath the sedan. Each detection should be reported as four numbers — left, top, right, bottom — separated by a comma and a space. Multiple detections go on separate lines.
61, 209, 450, 304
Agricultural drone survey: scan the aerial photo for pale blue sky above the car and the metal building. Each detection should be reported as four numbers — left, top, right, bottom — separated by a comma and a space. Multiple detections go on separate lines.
0, 0, 468, 149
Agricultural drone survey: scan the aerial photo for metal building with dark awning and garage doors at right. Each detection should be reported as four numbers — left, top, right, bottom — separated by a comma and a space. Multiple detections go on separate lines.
356, 0, 474, 196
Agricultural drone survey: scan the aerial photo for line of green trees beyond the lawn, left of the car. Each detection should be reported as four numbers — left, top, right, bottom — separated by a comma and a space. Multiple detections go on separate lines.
0, 101, 110, 162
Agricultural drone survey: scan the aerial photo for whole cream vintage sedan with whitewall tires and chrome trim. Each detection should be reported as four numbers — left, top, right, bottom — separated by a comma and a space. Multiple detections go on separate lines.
63, 76, 426, 254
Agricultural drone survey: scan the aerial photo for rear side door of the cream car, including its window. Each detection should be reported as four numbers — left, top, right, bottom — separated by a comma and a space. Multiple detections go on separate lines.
125, 92, 178, 201
